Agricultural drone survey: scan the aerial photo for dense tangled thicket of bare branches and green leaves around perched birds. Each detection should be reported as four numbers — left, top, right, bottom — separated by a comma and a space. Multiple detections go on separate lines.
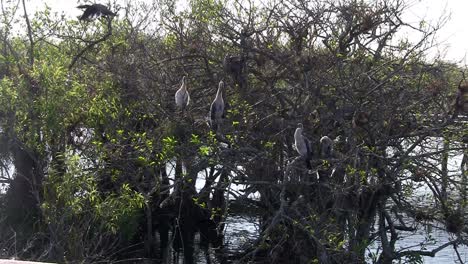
0, 0, 468, 263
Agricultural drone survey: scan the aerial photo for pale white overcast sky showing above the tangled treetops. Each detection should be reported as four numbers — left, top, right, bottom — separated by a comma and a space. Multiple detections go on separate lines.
23, 0, 468, 66
